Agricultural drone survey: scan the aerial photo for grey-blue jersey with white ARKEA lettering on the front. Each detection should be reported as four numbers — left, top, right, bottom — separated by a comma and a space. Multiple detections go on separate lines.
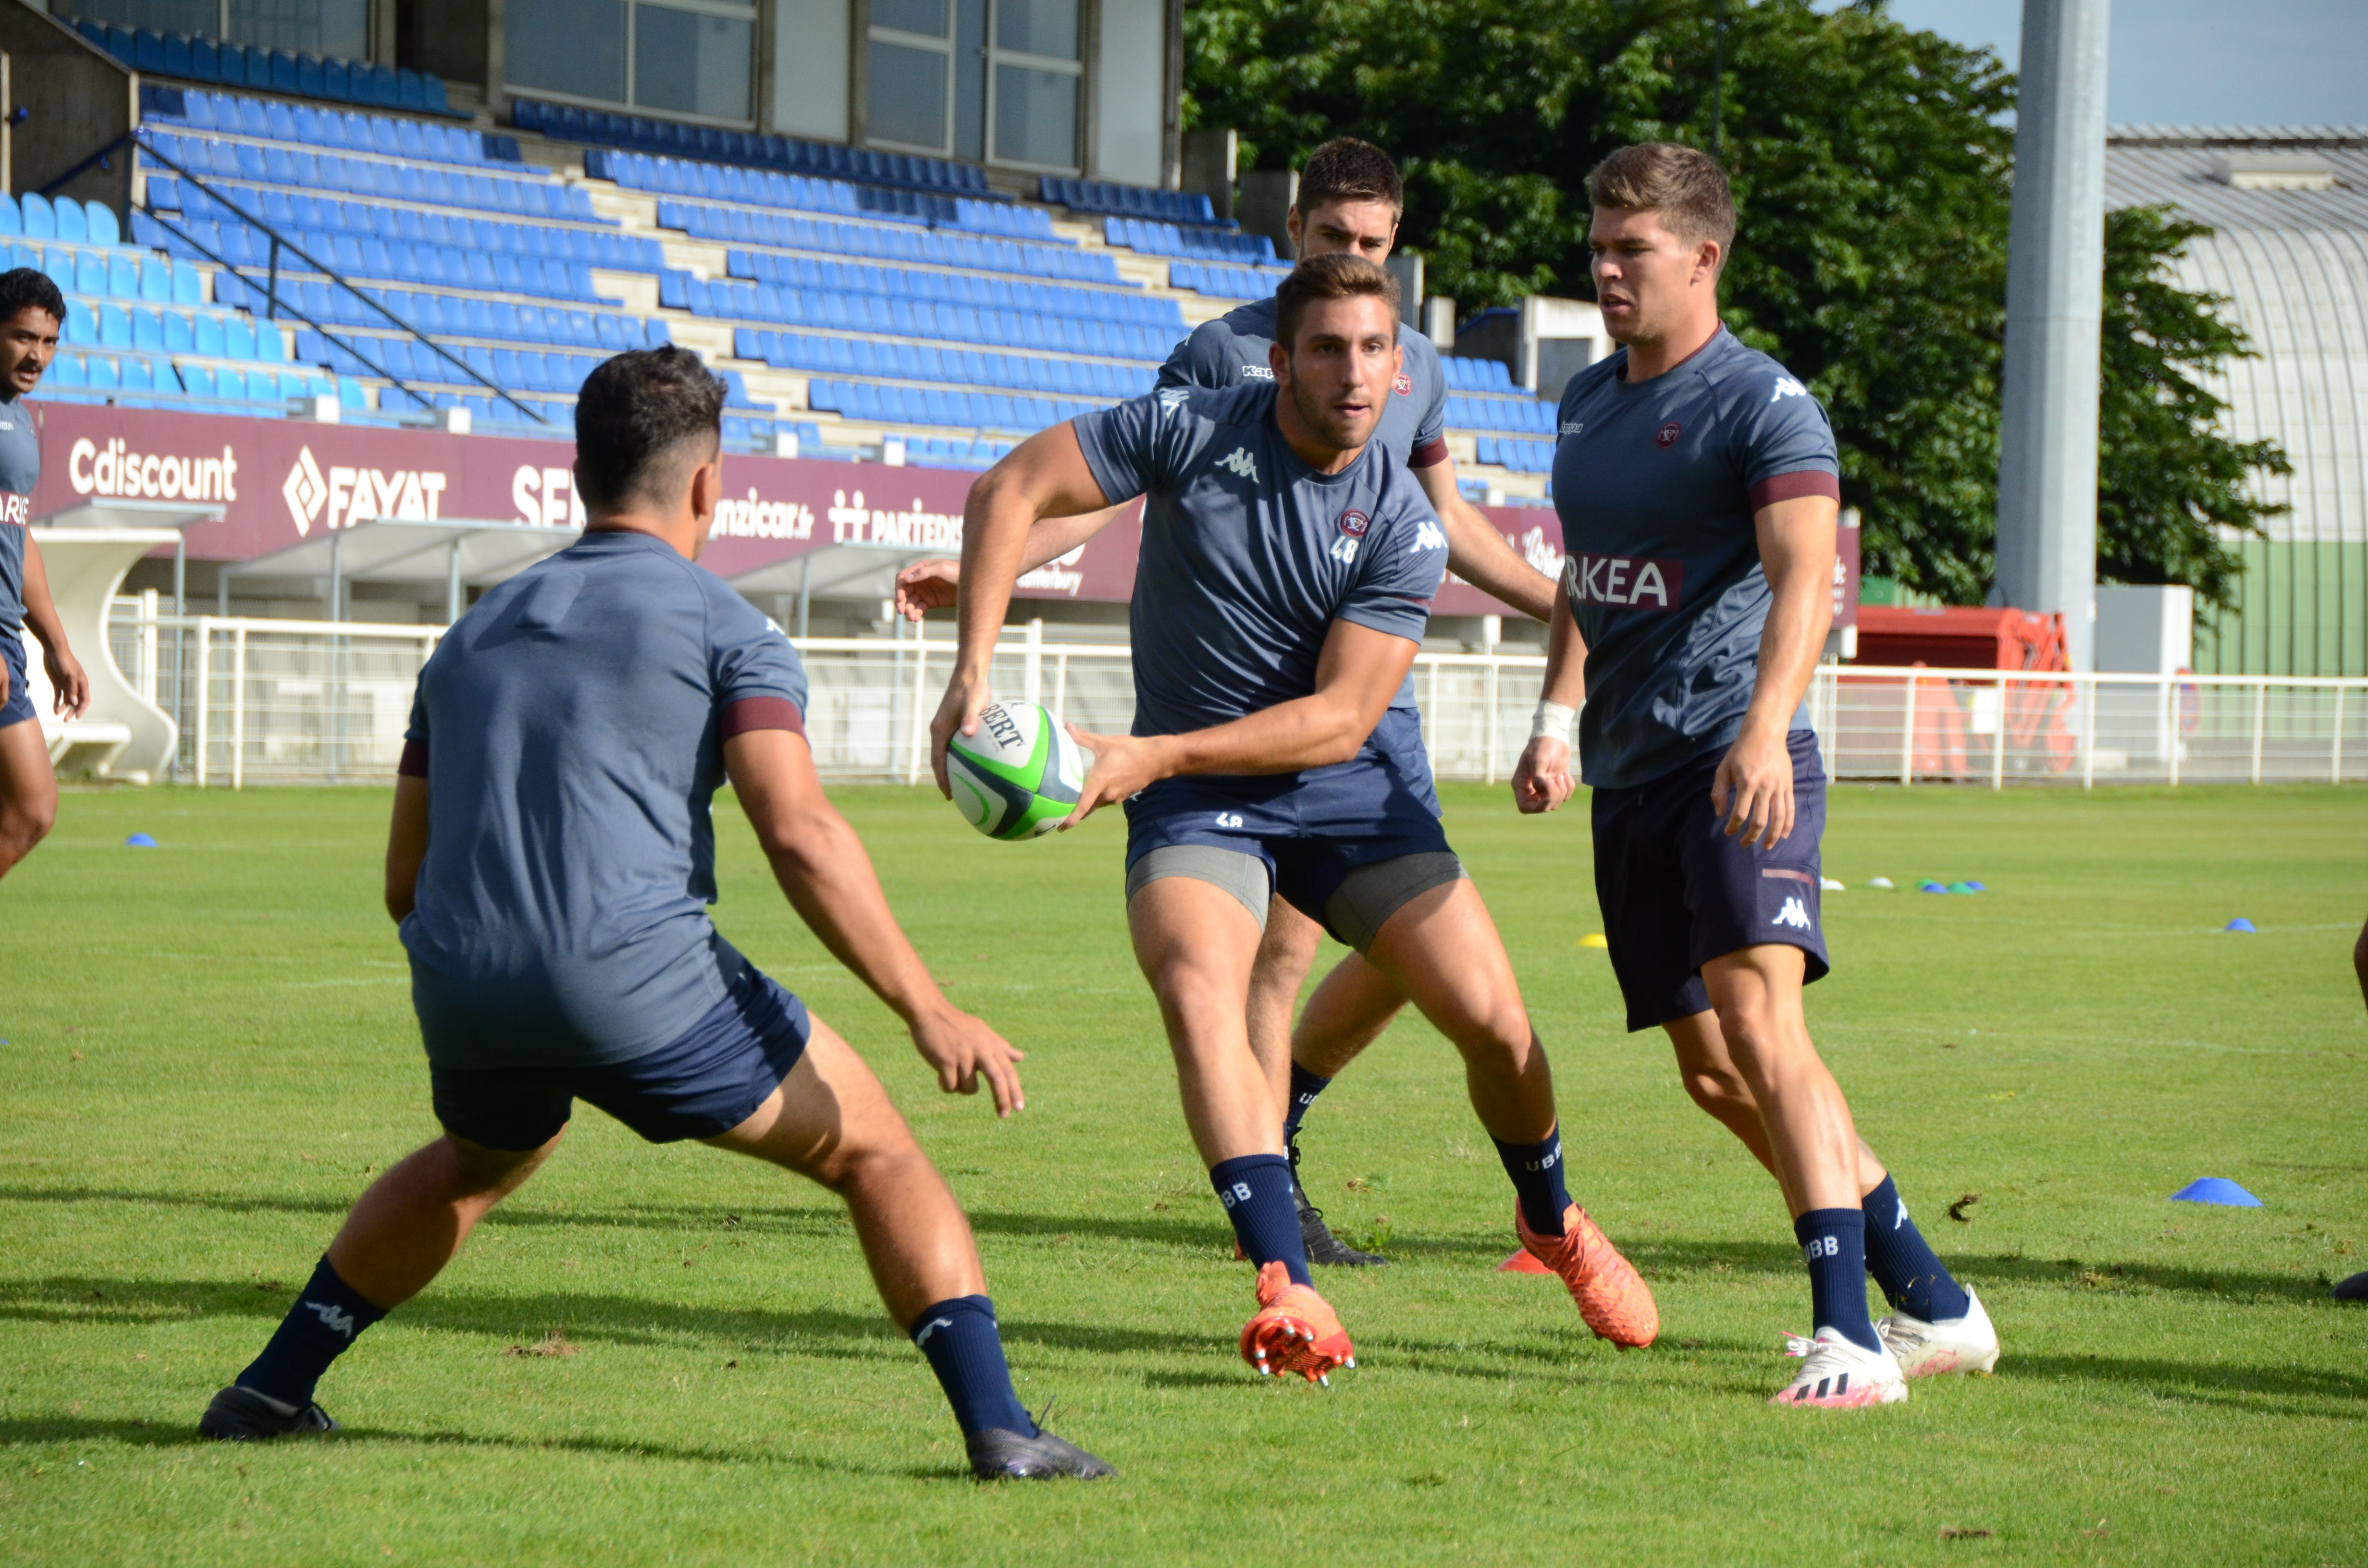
1554, 327, 1842, 789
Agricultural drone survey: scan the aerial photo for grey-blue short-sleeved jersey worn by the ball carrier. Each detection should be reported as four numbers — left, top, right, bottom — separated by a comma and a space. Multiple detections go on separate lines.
1075, 379, 1447, 734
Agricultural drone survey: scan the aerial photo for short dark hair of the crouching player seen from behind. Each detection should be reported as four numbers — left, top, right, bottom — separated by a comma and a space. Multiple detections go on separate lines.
576, 343, 727, 507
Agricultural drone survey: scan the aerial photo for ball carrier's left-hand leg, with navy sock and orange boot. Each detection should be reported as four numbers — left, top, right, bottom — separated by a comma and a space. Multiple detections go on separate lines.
1127, 876, 1357, 1381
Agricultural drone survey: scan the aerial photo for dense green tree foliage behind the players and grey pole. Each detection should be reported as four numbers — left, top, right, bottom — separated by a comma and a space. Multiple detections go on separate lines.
1184, 0, 2269, 604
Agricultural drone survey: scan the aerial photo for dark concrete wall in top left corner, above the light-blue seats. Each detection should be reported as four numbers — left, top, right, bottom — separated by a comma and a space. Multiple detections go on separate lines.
0, 0, 140, 227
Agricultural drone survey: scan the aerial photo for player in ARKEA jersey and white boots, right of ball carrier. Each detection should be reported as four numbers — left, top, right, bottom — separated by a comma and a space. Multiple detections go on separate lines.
1513, 142, 1998, 1407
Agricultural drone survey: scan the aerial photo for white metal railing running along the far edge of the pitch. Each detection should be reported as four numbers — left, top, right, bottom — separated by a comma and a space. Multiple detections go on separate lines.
109, 599, 2368, 789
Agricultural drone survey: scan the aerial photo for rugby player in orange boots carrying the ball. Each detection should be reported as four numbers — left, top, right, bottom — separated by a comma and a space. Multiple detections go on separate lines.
931, 256, 1658, 1379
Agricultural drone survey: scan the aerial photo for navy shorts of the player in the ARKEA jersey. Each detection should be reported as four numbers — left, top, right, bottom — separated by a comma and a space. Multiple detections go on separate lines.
1594, 730, 1830, 1030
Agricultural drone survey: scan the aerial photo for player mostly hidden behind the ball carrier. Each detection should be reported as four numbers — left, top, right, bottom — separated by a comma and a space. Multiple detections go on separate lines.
895, 137, 1554, 1267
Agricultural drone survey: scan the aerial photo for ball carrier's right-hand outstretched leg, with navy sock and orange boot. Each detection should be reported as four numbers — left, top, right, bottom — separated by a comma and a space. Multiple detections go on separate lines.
1366, 876, 1660, 1346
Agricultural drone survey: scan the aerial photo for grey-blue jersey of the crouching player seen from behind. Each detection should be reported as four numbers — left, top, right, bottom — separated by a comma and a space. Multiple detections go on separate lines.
403, 533, 805, 1068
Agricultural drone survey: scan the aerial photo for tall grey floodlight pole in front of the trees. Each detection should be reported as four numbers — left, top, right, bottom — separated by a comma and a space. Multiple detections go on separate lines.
1989, 0, 2108, 670
